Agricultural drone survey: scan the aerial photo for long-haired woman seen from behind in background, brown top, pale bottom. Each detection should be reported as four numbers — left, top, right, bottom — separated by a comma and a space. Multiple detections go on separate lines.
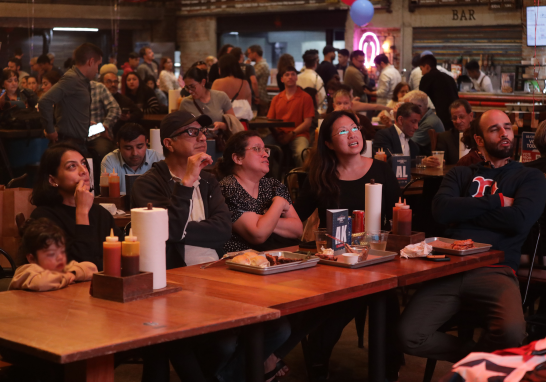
212, 54, 254, 121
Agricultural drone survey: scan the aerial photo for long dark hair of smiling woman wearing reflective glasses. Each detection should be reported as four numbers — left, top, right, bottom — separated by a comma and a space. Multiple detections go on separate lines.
309, 110, 366, 203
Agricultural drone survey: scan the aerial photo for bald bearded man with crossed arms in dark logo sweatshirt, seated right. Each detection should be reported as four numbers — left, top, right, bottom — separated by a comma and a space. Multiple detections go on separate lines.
399, 110, 546, 362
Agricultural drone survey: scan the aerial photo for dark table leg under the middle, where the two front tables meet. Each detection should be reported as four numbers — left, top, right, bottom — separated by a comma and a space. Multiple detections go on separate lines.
243, 323, 265, 382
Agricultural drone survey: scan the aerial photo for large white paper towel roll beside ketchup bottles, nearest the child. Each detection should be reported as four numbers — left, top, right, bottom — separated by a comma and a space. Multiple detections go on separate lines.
131, 208, 169, 289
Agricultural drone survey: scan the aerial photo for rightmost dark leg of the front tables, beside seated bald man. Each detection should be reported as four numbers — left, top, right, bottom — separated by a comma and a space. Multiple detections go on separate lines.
368, 292, 386, 382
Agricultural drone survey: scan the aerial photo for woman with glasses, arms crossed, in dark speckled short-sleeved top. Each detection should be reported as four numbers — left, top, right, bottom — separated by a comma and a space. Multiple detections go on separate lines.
218, 131, 303, 252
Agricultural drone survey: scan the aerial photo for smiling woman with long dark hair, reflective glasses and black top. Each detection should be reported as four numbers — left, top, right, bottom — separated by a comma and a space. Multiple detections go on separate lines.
295, 111, 400, 229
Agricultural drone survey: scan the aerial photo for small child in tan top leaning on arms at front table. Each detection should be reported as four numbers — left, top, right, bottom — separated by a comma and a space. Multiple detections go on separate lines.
9, 218, 97, 292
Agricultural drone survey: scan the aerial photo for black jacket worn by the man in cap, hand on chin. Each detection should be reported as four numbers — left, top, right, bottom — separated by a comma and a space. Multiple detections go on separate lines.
131, 161, 231, 269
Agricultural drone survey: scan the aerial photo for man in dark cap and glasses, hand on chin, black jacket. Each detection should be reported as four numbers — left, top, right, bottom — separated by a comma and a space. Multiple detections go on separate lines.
131, 111, 231, 269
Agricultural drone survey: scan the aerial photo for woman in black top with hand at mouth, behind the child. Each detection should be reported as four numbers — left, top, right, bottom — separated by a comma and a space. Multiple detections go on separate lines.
30, 143, 124, 271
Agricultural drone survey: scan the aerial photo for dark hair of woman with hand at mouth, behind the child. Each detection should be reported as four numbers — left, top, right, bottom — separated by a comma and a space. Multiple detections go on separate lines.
30, 142, 90, 206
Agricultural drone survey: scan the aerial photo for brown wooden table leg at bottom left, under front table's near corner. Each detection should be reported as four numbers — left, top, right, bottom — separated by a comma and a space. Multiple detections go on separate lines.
64, 354, 114, 382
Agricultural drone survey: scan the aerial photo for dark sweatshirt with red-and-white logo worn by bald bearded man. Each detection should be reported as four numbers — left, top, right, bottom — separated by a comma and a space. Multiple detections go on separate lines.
432, 161, 546, 271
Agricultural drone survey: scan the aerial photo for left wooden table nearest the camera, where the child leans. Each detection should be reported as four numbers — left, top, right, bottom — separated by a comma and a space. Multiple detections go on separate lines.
0, 282, 280, 382
